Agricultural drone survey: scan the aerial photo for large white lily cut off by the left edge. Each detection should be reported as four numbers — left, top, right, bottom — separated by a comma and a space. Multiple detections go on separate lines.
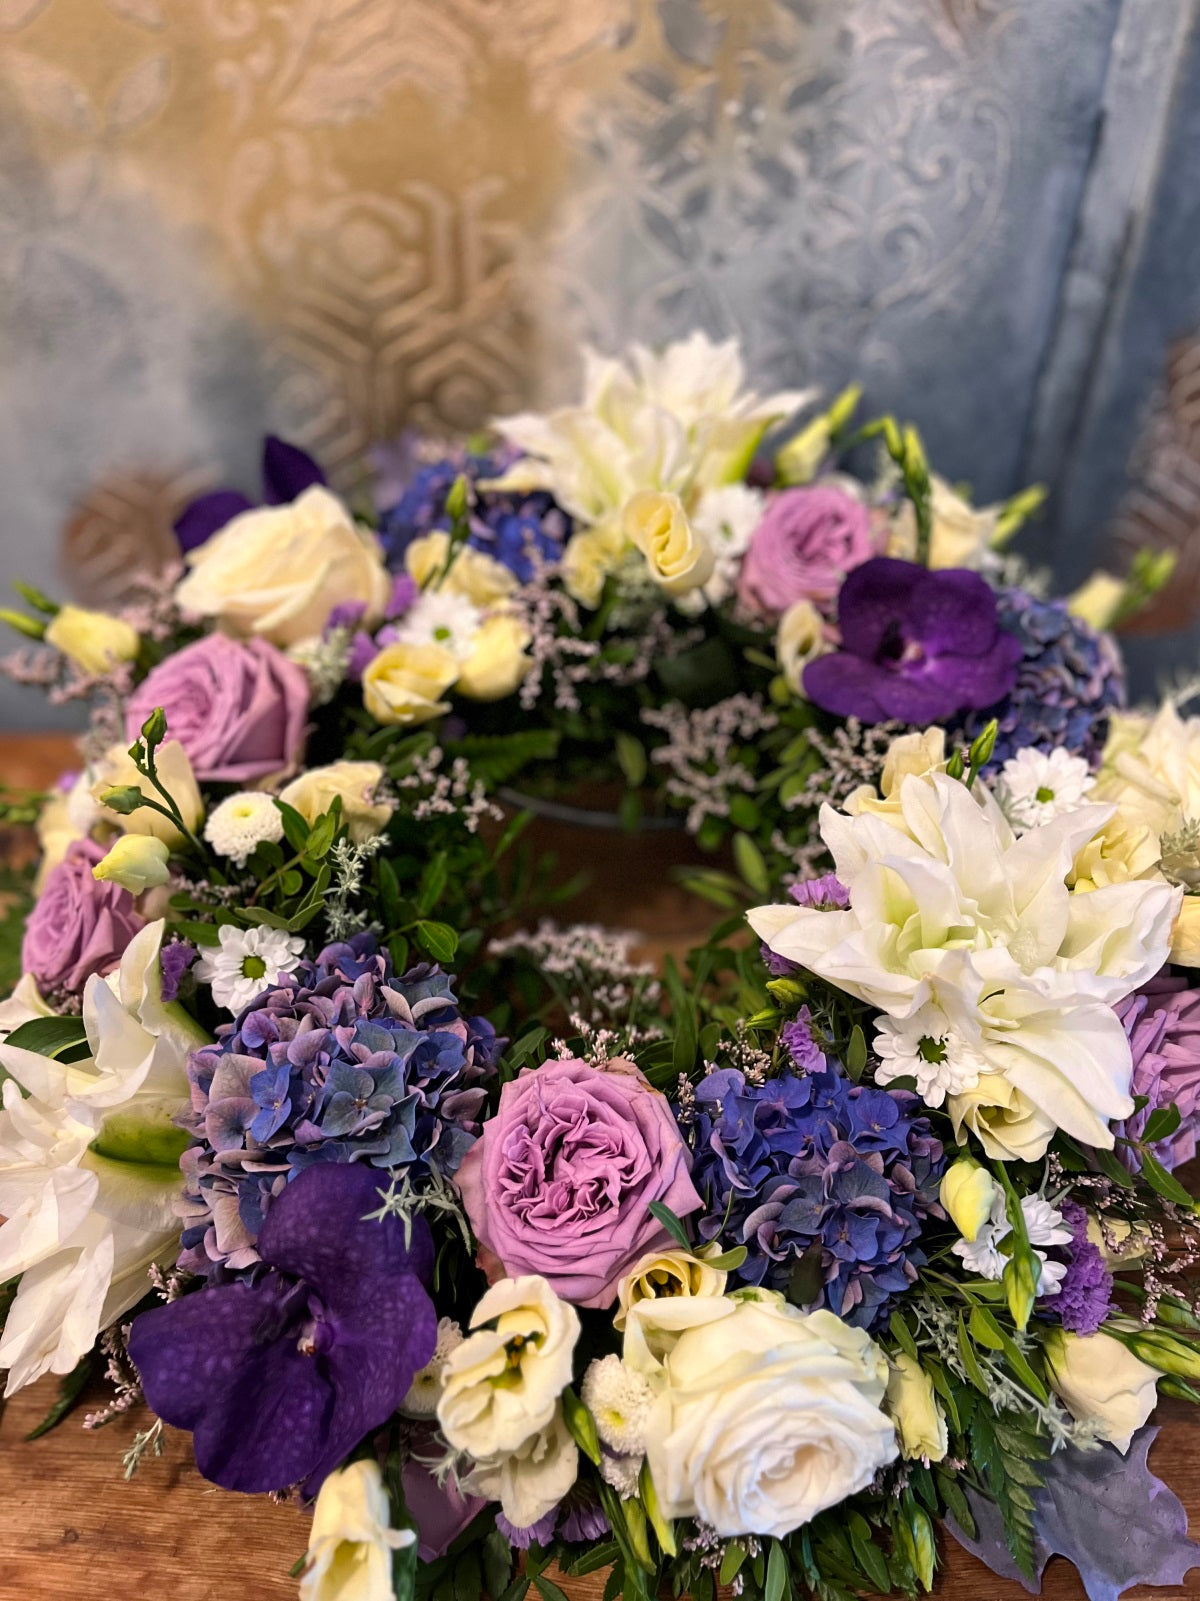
0, 922, 206, 1394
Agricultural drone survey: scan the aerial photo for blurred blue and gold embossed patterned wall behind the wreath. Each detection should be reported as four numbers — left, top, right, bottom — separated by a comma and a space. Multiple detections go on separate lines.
0, 0, 1200, 727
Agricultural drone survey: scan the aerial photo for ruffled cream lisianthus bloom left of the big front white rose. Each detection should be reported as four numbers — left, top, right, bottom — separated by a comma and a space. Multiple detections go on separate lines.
437, 1273, 579, 1466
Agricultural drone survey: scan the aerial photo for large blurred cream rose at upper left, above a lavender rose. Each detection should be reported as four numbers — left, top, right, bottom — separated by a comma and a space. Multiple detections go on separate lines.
174, 484, 392, 645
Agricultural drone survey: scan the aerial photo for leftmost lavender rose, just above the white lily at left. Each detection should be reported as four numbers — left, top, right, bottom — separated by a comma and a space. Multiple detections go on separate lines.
21, 839, 146, 994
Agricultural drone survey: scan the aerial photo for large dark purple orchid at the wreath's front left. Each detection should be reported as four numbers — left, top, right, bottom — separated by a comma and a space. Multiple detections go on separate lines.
130, 1164, 437, 1495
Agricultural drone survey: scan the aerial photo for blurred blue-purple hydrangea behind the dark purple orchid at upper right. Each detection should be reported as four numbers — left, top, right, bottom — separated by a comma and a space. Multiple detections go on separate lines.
962, 589, 1125, 773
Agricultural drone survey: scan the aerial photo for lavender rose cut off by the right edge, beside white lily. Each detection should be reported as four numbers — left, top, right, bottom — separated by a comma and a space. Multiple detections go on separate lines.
1115, 972, 1200, 1170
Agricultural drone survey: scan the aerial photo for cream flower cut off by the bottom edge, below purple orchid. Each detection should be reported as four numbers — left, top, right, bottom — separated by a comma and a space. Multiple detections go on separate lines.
299, 1462, 416, 1601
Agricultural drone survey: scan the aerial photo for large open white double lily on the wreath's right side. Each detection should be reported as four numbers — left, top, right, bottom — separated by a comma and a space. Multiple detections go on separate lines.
749, 772, 1181, 1159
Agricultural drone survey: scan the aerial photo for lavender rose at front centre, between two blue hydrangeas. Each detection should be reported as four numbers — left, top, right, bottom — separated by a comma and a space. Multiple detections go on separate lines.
454, 1057, 702, 1306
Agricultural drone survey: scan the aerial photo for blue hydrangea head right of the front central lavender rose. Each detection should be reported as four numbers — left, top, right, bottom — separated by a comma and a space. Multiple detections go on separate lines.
688, 1063, 946, 1329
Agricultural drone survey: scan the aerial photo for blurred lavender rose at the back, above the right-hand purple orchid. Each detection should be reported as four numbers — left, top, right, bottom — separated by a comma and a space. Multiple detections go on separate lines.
738, 485, 875, 616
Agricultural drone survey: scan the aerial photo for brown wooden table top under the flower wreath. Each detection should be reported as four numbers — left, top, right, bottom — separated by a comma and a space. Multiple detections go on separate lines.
0, 735, 1200, 1601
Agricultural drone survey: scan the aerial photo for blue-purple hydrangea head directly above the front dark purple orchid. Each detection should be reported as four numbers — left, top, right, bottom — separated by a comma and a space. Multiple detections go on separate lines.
179, 933, 501, 1276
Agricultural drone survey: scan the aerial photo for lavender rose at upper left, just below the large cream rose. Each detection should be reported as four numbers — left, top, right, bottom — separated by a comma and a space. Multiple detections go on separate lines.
125, 634, 309, 784
